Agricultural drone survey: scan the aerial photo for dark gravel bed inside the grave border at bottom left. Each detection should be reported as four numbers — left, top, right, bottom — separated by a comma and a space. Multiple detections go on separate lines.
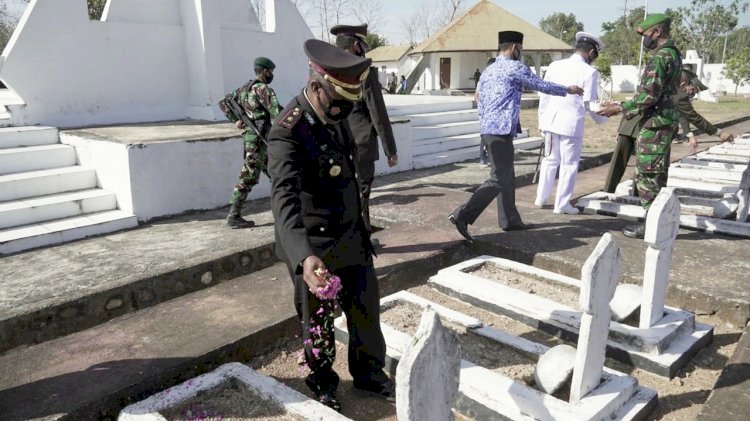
161, 379, 300, 421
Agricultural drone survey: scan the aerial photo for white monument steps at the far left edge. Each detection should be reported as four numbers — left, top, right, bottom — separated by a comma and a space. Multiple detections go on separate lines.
0, 126, 138, 255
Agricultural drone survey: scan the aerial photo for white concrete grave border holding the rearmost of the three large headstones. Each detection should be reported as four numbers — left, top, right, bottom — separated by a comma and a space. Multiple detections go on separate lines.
429, 256, 713, 377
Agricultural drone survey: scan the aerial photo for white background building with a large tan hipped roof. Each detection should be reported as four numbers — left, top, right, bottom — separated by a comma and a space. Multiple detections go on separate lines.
407, 0, 573, 93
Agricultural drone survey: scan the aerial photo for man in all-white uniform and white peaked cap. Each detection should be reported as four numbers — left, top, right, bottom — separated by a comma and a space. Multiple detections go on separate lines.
534, 32, 607, 215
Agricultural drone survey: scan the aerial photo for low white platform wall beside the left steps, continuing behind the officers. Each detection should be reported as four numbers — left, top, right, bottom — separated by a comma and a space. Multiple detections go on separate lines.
60, 118, 413, 221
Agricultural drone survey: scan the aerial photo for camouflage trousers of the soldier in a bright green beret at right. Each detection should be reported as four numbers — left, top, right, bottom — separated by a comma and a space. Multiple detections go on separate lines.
635, 122, 677, 210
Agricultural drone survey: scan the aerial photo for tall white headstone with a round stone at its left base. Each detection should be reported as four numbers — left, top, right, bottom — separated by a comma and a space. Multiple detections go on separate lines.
570, 233, 620, 402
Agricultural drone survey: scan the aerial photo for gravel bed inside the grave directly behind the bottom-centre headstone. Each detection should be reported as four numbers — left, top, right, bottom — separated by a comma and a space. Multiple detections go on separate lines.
380, 302, 536, 385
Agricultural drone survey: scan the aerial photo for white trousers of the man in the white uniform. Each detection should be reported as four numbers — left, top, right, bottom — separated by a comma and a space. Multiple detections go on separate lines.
536, 132, 583, 210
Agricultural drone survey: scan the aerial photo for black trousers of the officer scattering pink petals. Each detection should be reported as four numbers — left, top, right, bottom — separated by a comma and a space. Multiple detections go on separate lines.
287, 263, 385, 390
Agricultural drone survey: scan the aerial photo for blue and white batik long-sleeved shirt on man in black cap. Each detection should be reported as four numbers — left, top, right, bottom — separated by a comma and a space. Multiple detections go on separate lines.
477, 56, 568, 135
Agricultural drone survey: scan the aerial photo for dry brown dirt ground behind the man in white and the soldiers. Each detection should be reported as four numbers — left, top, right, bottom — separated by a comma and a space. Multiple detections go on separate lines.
521, 95, 750, 151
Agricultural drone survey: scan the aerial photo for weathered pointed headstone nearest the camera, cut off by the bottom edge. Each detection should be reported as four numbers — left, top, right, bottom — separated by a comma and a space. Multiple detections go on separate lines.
396, 308, 461, 421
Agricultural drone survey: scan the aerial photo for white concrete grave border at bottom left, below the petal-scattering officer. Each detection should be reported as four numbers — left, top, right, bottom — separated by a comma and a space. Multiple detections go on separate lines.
117, 363, 349, 421
